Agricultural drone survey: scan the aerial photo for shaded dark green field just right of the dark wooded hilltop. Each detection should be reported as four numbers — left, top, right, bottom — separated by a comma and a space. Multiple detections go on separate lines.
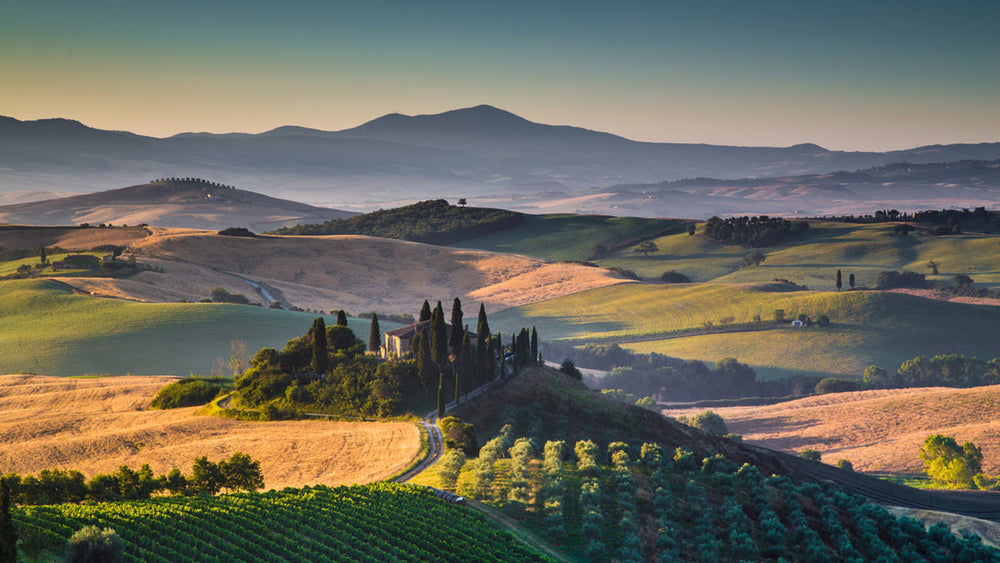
452, 213, 681, 260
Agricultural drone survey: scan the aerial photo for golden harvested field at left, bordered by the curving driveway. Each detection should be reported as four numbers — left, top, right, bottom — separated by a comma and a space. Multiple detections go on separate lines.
0, 375, 421, 489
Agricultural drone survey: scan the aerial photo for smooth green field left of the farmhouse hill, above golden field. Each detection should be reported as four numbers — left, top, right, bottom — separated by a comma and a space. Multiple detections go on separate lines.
0, 280, 397, 376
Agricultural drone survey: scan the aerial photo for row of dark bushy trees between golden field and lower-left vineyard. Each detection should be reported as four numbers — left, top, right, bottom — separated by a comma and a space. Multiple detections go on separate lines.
0, 452, 264, 505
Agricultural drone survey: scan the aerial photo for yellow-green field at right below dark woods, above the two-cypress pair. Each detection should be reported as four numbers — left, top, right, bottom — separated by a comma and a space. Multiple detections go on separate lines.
597, 223, 1000, 290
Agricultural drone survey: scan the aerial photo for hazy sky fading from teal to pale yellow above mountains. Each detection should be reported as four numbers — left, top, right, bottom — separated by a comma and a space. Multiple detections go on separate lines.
0, 0, 1000, 150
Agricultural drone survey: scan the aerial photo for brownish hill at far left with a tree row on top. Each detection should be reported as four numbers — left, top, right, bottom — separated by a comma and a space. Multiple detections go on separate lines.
0, 179, 354, 232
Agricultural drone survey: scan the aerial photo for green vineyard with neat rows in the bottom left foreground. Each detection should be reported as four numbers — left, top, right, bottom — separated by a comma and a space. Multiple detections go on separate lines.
12, 483, 545, 562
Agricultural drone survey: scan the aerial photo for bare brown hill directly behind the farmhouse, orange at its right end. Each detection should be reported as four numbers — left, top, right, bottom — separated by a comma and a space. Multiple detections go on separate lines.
107, 230, 624, 314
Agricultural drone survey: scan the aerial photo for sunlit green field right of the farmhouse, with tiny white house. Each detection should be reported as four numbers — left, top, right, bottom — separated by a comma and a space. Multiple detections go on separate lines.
490, 283, 1000, 378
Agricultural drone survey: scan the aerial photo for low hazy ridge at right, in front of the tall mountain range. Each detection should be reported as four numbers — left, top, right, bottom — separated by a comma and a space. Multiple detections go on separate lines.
504, 161, 1000, 218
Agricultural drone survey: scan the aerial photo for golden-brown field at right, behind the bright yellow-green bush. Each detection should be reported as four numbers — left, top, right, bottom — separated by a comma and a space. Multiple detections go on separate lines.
665, 386, 1000, 475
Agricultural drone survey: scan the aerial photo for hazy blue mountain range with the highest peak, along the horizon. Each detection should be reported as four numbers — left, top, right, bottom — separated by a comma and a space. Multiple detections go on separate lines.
0, 105, 1000, 215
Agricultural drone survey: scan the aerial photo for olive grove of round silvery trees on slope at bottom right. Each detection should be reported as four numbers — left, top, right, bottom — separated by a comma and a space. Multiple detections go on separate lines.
441, 426, 1000, 562
